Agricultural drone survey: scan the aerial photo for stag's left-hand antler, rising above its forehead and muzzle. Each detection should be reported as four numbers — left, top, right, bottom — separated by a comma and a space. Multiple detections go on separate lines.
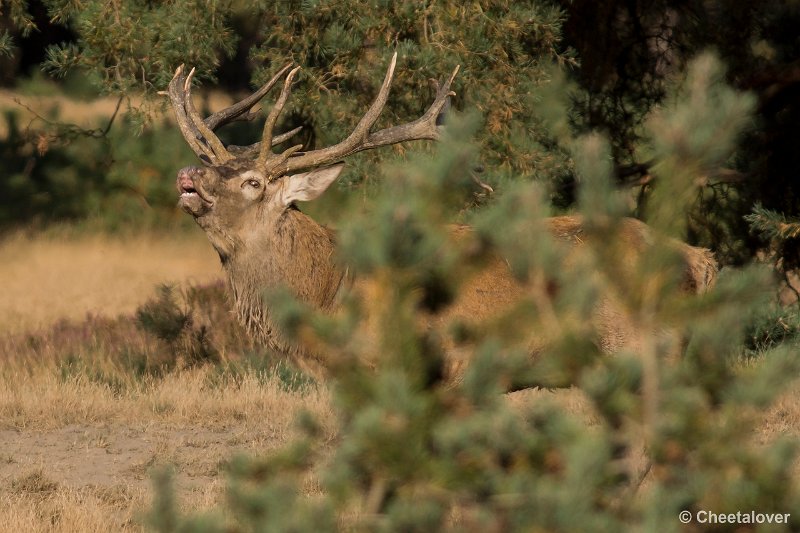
166, 63, 302, 165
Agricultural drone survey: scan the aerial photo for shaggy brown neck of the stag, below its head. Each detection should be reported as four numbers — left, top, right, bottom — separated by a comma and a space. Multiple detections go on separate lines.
220, 209, 346, 350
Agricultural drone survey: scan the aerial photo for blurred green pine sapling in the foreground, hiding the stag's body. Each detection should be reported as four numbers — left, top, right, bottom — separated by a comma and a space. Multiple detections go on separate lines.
148, 59, 800, 532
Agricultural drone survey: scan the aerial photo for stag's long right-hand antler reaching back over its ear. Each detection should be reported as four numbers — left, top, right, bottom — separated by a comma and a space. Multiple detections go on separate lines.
285, 53, 460, 172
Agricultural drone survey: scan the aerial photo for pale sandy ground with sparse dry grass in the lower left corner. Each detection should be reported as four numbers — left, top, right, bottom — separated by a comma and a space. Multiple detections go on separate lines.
0, 410, 332, 533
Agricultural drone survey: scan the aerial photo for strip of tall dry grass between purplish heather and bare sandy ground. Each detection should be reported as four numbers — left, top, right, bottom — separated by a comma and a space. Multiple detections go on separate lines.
0, 362, 329, 432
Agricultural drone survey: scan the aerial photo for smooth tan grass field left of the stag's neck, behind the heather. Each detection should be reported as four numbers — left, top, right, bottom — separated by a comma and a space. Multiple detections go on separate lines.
0, 231, 222, 333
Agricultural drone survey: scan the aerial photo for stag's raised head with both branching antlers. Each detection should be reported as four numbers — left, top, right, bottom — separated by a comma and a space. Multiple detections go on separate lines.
166, 53, 458, 260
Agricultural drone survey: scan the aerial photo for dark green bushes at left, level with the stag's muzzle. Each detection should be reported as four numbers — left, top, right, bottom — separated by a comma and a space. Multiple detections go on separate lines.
0, 110, 197, 232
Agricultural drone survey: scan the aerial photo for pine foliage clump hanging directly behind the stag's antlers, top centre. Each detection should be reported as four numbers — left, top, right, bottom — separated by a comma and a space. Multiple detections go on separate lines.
244, 0, 574, 182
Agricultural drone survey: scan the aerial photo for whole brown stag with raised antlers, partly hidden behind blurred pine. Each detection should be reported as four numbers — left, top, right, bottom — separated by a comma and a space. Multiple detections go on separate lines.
167, 54, 716, 377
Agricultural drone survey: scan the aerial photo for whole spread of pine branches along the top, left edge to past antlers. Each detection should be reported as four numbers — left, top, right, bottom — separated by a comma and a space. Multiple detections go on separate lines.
0, 0, 575, 191
